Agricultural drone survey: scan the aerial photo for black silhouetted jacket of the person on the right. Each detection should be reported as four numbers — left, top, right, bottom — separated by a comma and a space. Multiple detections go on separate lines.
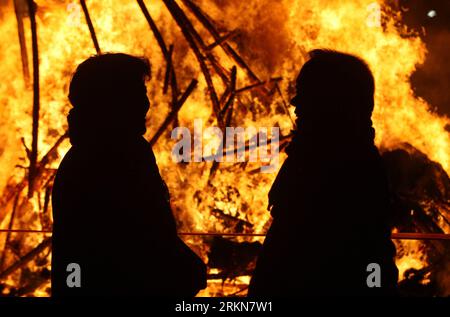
249, 132, 398, 296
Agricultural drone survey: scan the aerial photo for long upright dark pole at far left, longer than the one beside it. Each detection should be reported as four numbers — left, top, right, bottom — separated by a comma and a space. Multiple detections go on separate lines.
27, 0, 39, 198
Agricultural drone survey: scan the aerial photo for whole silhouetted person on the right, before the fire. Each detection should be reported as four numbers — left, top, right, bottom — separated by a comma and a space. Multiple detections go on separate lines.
249, 50, 398, 296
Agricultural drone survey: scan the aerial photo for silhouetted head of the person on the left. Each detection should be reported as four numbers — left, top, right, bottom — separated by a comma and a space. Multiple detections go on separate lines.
68, 54, 150, 144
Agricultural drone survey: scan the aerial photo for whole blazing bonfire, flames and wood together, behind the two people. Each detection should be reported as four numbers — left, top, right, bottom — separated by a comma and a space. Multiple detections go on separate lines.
0, 0, 450, 296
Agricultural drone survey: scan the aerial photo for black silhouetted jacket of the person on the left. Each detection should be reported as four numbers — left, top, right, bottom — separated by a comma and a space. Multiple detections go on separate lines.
52, 137, 206, 296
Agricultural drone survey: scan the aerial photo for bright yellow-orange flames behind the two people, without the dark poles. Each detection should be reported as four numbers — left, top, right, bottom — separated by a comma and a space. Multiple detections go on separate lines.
0, 0, 450, 296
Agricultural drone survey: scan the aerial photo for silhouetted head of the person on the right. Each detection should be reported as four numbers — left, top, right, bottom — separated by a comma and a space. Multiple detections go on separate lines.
291, 50, 375, 139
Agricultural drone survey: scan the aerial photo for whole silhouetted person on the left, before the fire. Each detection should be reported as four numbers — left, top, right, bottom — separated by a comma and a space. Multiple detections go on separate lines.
52, 54, 206, 296
